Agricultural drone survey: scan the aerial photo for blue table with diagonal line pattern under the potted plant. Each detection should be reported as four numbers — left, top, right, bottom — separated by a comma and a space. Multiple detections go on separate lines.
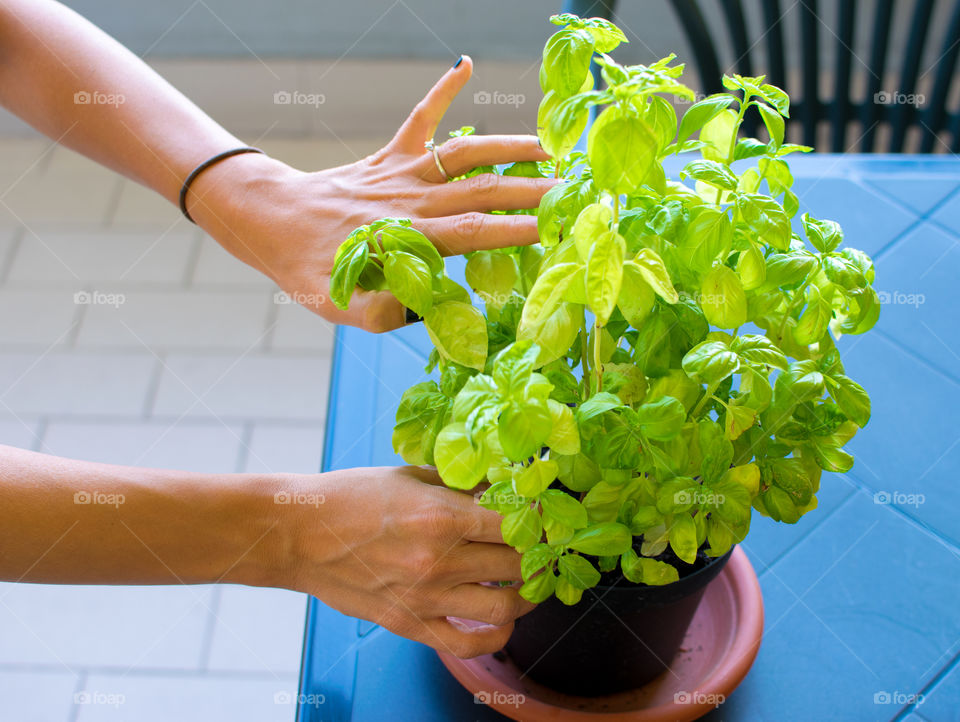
298, 155, 960, 722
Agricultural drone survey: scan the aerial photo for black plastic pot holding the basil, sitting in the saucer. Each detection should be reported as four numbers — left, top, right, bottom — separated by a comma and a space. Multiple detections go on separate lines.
506, 548, 733, 697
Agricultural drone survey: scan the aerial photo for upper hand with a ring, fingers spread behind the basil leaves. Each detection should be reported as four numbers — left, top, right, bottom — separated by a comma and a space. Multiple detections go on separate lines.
189, 57, 556, 332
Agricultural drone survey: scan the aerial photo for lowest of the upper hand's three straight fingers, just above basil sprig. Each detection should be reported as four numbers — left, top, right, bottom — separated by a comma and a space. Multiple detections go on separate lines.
413, 212, 540, 256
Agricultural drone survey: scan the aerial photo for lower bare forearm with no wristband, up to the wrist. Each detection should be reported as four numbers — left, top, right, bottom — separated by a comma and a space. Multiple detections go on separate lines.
0, 446, 299, 586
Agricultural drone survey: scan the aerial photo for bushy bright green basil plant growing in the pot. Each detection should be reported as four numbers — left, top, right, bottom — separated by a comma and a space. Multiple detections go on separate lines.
332, 15, 880, 604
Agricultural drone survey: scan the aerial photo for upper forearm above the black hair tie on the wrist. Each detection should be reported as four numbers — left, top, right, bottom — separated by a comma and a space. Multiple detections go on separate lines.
0, 0, 242, 202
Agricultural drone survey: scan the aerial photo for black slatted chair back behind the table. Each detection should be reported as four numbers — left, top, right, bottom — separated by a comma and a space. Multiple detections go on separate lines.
564, 0, 960, 153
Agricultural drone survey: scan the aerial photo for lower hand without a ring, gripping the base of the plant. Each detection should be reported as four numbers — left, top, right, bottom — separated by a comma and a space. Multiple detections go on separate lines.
285, 466, 534, 657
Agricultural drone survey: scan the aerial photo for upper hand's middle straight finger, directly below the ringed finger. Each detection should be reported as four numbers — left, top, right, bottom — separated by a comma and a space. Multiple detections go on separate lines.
424, 173, 559, 216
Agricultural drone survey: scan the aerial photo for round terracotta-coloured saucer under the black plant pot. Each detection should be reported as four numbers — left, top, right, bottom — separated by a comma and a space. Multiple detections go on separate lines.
439, 547, 763, 722
